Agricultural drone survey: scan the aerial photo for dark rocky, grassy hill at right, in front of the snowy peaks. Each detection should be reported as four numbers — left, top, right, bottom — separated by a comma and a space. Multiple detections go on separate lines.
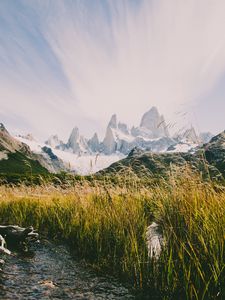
99, 131, 225, 180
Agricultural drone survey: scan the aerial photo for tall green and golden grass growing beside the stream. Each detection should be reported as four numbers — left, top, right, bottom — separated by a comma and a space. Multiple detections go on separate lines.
0, 172, 225, 299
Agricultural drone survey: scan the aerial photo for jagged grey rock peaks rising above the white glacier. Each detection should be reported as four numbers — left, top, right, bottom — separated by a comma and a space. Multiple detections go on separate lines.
45, 107, 212, 155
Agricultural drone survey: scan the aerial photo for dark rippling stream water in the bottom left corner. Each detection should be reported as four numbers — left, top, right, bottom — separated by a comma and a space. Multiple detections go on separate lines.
0, 241, 135, 300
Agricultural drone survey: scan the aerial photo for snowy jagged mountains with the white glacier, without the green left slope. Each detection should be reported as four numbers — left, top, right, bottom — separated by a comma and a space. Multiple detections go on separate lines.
7, 107, 213, 174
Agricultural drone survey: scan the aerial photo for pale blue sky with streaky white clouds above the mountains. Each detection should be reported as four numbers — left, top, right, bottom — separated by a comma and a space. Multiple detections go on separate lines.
0, 0, 225, 141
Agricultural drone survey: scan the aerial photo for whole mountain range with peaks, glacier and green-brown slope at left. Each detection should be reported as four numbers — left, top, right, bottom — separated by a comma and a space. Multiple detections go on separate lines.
0, 107, 217, 175
